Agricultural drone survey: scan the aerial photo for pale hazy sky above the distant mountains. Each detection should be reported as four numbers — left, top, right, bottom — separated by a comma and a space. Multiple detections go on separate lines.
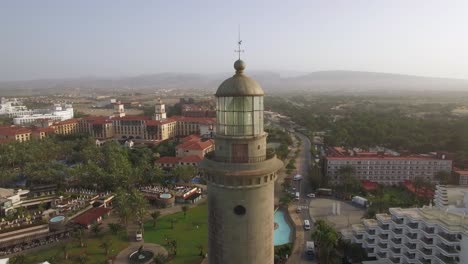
0, 0, 468, 80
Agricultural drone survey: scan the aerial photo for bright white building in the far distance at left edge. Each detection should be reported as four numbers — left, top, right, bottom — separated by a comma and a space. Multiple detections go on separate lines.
13, 104, 73, 125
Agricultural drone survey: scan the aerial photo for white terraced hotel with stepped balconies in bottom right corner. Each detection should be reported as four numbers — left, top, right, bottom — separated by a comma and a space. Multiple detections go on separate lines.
341, 186, 468, 264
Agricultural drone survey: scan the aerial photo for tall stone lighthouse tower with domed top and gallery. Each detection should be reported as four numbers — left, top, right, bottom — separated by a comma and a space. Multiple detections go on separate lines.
201, 59, 283, 264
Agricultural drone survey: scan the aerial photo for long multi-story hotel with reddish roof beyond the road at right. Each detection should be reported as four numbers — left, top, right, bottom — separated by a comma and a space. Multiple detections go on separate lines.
324, 147, 452, 185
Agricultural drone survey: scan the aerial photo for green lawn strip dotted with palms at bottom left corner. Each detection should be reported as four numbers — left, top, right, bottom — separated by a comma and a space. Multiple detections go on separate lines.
24, 234, 128, 264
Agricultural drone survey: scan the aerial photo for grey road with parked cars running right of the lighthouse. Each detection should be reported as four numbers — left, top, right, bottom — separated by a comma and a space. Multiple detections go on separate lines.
288, 133, 314, 264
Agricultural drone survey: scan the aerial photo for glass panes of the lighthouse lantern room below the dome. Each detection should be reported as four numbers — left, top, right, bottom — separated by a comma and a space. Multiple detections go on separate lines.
216, 96, 263, 136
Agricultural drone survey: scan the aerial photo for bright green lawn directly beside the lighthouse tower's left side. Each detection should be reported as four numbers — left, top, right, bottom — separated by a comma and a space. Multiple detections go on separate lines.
144, 203, 208, 264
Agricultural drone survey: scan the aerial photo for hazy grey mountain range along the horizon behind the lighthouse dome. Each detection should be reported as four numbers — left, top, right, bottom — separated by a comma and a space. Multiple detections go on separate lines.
0, 71, 468, 94
